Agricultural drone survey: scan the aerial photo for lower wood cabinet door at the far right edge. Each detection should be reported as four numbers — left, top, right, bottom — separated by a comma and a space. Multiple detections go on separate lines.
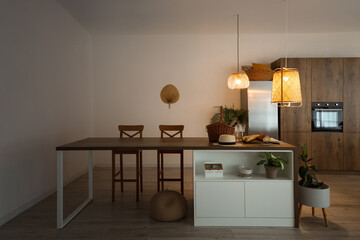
344, 133, 360, 171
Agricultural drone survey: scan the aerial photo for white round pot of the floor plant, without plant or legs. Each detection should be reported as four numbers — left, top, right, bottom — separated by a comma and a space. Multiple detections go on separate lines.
299, 184, 330, 208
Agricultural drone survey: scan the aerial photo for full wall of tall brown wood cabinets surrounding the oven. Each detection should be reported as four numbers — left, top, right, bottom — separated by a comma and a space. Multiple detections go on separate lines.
271, 58, 360, 171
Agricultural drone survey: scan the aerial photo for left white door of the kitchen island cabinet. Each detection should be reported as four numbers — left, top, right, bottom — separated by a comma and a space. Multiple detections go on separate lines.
195, 181, 245, 217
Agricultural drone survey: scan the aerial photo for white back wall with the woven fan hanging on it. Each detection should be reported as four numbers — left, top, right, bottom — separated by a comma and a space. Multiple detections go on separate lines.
93, 32, 360, 165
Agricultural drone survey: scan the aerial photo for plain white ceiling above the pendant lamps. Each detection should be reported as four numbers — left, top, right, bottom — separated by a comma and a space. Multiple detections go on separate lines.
57, 0, 360, 34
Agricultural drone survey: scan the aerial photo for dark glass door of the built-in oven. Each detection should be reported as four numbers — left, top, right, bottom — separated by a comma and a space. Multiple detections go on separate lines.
311, 108, 343, 132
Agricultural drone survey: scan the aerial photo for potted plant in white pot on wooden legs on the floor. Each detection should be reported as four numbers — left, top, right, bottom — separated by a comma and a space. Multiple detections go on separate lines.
299, 144, 330, 222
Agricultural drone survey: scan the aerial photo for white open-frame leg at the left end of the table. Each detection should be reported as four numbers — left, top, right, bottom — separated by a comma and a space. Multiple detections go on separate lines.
57, 151, 93, 229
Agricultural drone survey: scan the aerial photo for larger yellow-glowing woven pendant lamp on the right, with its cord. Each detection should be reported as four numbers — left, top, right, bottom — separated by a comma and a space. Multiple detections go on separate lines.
271, 0, 302, 107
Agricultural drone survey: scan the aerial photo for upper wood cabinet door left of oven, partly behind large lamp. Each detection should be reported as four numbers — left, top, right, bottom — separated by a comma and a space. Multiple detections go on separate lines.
279, 58, 311, 132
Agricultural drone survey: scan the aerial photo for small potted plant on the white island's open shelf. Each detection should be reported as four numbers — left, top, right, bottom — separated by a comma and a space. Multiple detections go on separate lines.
256, 152, 287, 179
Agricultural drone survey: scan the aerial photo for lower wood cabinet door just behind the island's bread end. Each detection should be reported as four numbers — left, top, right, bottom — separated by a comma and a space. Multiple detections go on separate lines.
280, 132, 311, 166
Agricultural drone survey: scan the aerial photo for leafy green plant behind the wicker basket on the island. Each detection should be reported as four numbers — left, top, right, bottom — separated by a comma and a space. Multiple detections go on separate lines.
210, 106, 248, 127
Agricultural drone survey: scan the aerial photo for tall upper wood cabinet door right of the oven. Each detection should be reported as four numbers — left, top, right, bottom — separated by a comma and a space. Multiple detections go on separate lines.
344, 58, 360, 132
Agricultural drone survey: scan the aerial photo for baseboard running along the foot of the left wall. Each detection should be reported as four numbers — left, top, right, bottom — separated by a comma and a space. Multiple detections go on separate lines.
0, 168, 88, 227
